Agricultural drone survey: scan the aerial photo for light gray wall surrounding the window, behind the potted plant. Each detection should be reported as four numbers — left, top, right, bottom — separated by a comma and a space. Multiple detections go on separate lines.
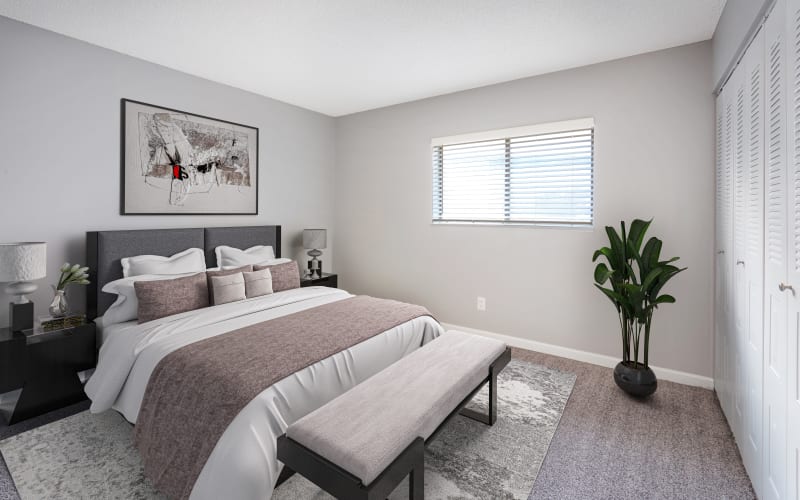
335, 42, 714, 376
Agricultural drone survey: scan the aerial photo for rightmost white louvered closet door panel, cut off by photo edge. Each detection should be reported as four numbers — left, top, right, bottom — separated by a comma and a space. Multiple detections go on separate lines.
786, 0, 800, 499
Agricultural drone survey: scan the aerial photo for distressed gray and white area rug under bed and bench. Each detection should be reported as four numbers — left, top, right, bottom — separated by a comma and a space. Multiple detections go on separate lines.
0, 360, 575, 500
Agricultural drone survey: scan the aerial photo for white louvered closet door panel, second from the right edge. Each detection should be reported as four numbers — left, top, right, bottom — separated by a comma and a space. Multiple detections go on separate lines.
762, 0, 793, 499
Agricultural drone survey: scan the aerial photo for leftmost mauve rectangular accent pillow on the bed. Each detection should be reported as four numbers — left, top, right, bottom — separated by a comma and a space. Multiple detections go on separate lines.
133, 273, 208, 323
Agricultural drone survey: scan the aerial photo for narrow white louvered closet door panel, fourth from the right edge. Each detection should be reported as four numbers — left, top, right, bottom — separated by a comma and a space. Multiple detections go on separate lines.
728, 63, 749, 442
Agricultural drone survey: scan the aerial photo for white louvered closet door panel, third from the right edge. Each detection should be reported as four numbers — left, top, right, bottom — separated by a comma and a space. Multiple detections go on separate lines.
734, 26, 764, 492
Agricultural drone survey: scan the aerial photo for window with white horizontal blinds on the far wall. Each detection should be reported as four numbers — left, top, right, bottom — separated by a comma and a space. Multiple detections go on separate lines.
432, 119, 594, 225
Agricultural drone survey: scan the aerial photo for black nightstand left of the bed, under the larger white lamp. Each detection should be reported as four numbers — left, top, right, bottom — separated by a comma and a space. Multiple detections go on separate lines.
0, 323, 97, 425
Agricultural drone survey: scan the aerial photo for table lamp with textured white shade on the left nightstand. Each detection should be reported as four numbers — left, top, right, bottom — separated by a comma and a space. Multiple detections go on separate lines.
0, 242, 47, 332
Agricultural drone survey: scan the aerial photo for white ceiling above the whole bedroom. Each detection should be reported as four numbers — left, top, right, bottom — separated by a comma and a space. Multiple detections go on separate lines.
0, 0, 725, 116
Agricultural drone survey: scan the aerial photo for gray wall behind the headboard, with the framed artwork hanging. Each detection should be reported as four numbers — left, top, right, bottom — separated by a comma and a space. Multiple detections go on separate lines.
0, 17, 335, 325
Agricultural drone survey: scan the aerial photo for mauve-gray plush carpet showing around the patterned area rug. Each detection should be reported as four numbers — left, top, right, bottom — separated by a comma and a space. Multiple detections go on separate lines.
0, 349, 755, 500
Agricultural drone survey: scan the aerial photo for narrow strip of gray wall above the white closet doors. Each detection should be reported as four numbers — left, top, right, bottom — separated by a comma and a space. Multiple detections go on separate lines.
711, 0, 775, 90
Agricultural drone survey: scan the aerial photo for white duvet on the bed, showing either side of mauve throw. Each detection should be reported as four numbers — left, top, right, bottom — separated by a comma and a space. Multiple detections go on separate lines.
86, 287, 443, 499
